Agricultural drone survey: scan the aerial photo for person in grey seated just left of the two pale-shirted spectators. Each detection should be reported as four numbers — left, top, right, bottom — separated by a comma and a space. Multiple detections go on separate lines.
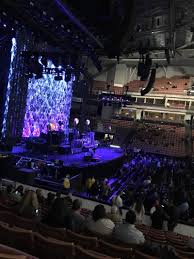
70, 199, 85, 232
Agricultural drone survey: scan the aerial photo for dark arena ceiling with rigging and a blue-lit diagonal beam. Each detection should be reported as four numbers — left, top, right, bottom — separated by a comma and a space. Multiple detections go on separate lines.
0, 0, 194, 64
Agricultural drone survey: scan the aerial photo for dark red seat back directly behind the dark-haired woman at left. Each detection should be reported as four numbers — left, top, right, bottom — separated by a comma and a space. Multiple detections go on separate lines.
38, 223, 66, 241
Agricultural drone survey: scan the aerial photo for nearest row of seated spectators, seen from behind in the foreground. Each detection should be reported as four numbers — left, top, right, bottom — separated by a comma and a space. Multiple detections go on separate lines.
0, 180, 193, 258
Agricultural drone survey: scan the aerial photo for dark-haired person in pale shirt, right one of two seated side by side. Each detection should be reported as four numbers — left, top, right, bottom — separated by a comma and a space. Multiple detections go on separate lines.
113, 210, 145, 245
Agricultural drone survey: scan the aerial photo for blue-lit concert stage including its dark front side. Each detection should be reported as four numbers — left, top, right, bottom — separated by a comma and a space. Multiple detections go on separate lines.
1, 146, 124, 185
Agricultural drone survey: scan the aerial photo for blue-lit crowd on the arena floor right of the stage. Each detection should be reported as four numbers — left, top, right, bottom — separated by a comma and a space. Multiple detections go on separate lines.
86, 151, 194, 230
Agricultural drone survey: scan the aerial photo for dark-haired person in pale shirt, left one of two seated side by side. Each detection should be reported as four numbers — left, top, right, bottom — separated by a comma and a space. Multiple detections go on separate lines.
86, 204, 115, 236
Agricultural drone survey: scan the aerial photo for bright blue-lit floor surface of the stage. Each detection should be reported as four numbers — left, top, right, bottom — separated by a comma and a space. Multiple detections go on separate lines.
12, 146, 124, 168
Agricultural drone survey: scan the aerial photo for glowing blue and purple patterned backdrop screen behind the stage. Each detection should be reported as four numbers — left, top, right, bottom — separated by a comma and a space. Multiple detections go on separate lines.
23, 61, 73, 137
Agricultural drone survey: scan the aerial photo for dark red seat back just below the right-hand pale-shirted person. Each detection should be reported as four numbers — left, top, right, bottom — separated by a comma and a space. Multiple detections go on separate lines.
98, 239, 134, 259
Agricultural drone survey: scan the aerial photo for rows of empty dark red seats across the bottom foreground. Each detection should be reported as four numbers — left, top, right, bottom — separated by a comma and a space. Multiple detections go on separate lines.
0, 211, 194, 259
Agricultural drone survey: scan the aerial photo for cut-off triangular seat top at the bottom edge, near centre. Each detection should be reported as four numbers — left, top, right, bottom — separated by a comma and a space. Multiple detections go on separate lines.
75, 246, 119, 259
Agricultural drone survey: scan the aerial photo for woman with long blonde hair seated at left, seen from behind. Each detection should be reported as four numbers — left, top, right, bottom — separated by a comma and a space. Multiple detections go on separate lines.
19, 190, 40, 218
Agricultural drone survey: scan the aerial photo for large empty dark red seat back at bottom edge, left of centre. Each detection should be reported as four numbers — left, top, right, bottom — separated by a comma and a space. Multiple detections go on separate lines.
34, 233, 75, 259
